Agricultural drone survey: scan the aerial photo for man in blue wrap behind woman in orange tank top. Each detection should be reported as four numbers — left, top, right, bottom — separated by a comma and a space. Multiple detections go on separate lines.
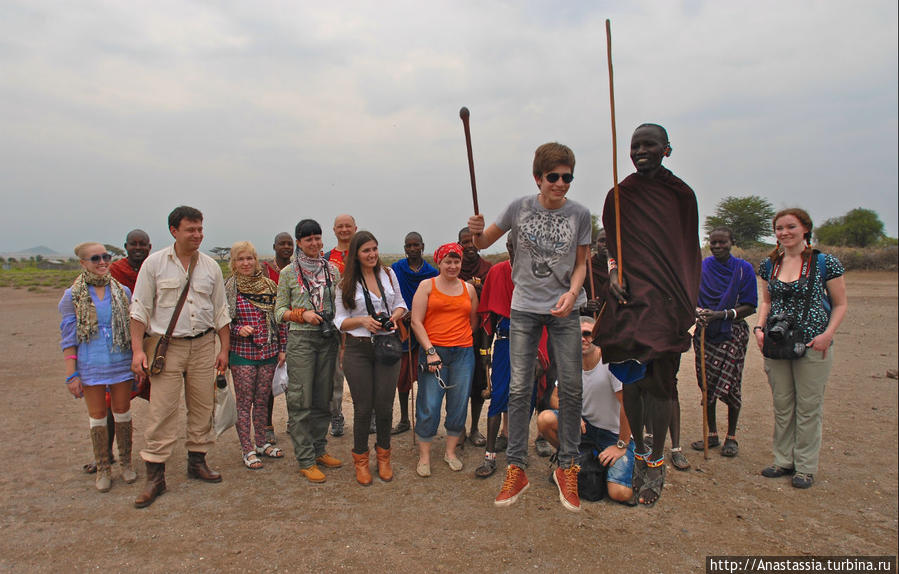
390, 231, 439, 434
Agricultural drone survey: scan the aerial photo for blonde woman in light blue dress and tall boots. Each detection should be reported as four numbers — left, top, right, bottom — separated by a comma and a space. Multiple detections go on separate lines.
59, 242, 137, 492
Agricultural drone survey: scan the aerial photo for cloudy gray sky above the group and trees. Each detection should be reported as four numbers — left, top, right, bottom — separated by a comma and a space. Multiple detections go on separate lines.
0, 0, 899, 253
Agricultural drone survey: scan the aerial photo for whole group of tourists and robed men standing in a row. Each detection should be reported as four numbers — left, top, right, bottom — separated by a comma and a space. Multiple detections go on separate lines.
59, 124, 847, 511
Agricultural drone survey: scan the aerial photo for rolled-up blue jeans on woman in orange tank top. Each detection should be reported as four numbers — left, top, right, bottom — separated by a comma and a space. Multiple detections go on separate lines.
415, 347, 474, 442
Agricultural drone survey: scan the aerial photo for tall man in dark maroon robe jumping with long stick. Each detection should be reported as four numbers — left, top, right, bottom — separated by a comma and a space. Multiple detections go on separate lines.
596, 124, 701, 505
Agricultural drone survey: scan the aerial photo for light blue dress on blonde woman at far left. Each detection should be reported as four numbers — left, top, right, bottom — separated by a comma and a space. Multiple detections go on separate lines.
59, 285, 134, 385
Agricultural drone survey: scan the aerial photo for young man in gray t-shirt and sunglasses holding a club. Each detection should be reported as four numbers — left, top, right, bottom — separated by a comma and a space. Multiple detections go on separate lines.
468, 143, 592, 511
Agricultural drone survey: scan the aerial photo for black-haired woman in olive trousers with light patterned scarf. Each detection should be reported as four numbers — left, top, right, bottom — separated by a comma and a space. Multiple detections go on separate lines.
275, 219, 342, 483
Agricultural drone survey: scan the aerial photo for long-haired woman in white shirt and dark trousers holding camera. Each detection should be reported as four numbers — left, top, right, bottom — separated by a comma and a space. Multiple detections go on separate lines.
334, 231, 407, 486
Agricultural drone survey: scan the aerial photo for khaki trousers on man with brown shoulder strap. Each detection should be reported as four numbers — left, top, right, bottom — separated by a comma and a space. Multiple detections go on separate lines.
140, 332, 215, 462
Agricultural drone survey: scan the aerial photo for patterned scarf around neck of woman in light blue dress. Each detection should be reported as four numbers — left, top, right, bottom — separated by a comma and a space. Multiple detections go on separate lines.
72, 269, 131, 351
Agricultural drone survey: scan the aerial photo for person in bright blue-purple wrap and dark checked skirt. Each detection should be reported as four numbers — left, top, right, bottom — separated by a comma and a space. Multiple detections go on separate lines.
692, 227, 759, 459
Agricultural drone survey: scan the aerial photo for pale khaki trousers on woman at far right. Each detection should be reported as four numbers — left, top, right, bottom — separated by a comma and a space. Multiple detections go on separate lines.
765, 347, 833, 474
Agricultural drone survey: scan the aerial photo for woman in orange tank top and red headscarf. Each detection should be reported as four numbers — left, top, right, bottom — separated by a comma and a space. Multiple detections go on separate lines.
412, 243, 478, 477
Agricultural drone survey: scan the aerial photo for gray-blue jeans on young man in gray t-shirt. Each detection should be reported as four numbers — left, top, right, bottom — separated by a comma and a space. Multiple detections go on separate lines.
506, 309, 583, 468
